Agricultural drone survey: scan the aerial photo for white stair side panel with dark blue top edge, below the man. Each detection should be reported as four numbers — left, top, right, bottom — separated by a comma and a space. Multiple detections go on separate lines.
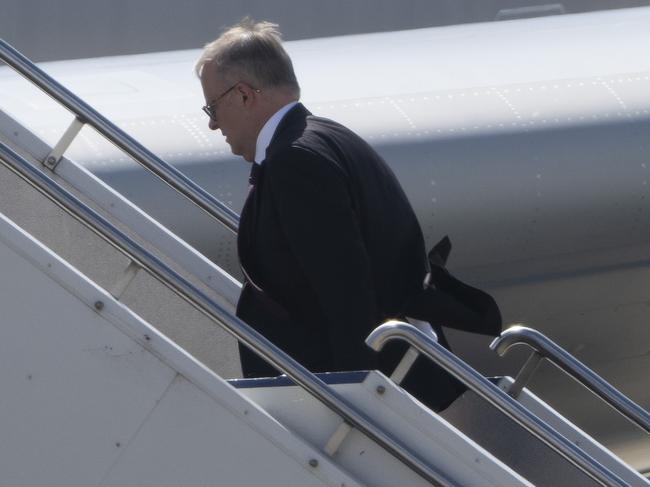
241, 371, 532, 487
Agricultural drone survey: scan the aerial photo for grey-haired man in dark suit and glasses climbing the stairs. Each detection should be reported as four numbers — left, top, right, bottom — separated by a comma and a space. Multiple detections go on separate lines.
197, 20, 498, 410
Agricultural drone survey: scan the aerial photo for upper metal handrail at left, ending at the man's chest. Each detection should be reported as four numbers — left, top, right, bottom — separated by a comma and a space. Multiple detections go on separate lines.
0, 39, 239, 234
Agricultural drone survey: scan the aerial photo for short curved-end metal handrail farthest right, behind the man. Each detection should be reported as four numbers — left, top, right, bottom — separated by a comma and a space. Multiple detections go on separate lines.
490, 325, 650, 433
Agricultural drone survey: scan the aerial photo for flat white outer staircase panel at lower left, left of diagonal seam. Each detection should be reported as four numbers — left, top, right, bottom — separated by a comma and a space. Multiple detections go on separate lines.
0, 235, 175, 487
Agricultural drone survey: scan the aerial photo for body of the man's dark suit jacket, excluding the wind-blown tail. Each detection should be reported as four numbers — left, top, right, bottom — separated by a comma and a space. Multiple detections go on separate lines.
237, 104, 427, 377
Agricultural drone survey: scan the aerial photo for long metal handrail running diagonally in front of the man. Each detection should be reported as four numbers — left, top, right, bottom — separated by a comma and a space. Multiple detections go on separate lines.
0, 142, 454, 487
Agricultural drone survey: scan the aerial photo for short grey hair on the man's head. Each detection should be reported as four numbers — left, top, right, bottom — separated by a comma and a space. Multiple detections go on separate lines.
195, 18, 300, 95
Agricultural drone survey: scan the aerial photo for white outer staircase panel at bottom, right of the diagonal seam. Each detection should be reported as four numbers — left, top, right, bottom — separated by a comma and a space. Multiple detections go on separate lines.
101, 376, 334, 487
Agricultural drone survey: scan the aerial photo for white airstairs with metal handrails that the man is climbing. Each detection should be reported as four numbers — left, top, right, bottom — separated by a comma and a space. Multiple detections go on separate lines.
0, 41, 650, 487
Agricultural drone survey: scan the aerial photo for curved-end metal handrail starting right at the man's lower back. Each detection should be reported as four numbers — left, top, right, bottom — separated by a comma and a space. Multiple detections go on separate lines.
366, 321, 628, 487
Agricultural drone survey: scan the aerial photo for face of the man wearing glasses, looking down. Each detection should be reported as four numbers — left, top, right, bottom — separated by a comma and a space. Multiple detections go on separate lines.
201, 64, 257, 162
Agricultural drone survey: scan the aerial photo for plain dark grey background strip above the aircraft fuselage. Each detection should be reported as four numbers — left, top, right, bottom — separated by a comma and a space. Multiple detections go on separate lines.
0, 0, 650, 61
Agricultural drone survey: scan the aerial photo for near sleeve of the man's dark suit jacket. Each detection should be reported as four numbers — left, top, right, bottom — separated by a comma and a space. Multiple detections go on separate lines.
266, 147, 379, 370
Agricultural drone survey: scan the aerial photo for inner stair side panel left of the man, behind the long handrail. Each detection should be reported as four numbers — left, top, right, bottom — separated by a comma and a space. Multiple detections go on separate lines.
0, 110, 241, 377
